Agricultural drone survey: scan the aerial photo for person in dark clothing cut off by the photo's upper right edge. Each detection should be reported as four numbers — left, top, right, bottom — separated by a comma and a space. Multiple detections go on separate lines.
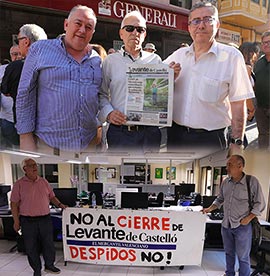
254, 30, 270, 149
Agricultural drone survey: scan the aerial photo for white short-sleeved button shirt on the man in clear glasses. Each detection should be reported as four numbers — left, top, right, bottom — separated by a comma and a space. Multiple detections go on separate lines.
164, 41, 254, 131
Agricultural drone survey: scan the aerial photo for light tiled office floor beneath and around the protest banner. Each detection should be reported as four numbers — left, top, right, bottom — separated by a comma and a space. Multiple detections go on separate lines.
0, 240, 230, 276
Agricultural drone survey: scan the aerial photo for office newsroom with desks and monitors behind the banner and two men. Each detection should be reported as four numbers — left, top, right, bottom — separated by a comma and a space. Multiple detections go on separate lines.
0, 150, 270, 221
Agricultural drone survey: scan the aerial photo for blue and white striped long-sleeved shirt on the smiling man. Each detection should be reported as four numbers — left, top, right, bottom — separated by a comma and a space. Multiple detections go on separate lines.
16, 38, 102, 151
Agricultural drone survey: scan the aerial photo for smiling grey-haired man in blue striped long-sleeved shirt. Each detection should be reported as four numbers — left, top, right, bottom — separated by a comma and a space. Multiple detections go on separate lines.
16, 5, 101, 153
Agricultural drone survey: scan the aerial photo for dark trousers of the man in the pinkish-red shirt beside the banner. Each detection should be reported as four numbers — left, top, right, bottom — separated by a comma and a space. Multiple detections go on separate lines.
20, 215, 55, 273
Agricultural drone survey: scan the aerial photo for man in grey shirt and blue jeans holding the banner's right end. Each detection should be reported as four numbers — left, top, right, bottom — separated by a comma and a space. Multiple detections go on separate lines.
203, 155, 265, 276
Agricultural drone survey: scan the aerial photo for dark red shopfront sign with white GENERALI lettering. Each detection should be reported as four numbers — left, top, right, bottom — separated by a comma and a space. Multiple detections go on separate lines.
6, 0, 188, 31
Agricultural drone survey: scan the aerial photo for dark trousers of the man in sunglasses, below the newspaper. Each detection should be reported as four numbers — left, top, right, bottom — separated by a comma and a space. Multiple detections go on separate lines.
107, 124, 161, 152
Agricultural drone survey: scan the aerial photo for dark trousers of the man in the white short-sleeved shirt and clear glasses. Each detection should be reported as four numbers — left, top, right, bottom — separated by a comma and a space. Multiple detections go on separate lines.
167, 122, 227, 151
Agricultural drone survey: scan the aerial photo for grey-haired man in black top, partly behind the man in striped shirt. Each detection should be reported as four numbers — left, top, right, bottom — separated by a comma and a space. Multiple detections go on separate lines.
1, 24, 47, 124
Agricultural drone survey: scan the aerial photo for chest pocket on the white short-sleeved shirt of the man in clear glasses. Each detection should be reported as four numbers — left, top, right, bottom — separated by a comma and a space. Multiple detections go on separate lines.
198, 76, 223, 103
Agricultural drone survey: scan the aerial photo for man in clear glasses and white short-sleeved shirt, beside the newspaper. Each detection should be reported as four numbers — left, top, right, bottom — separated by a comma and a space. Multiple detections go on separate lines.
165, 1, 254, 152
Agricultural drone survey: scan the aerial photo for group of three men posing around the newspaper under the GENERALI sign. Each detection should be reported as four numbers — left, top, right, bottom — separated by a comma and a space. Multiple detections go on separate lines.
2, 2, 254, 152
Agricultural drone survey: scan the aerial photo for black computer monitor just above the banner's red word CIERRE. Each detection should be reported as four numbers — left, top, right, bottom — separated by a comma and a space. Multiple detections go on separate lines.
121, 192, 148, 209
